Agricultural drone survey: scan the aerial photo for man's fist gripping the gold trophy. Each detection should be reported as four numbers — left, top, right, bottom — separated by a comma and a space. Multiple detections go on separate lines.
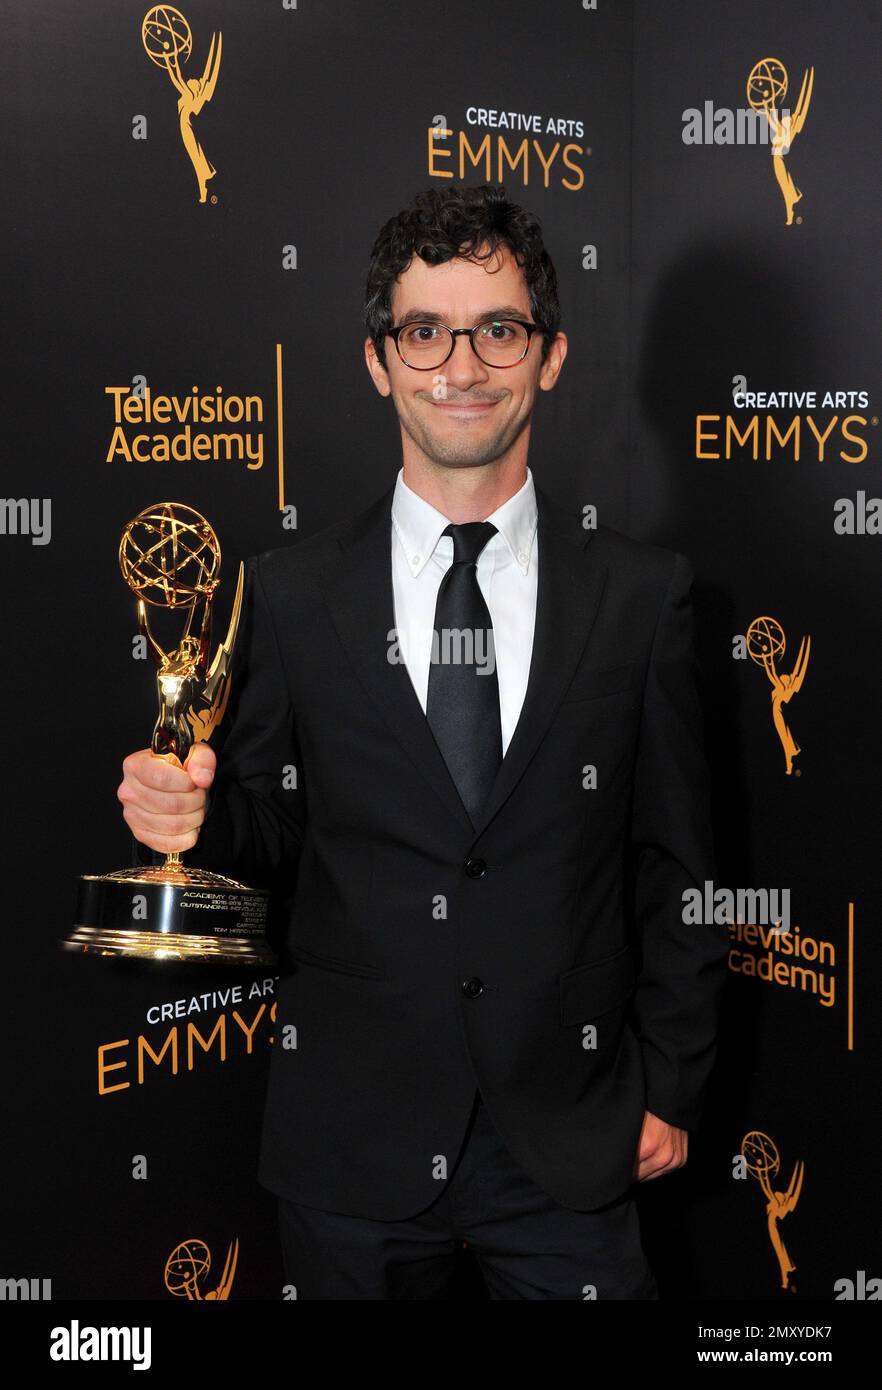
117, 744, 217, 855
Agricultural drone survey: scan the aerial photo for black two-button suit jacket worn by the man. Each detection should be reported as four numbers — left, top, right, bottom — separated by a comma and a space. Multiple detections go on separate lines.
141, 488, 726, 1219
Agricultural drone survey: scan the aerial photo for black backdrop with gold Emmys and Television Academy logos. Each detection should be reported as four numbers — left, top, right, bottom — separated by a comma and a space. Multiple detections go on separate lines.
0, 0, 882, 1301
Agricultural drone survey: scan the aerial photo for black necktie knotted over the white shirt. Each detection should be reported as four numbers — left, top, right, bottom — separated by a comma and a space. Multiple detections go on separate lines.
425, 521, 503, 821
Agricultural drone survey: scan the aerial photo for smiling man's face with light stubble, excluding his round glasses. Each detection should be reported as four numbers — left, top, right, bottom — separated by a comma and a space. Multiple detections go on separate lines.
365, 246, 565, 468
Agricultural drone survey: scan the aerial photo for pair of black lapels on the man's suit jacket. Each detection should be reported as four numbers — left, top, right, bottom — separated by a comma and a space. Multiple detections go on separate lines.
322, 487, 607, 838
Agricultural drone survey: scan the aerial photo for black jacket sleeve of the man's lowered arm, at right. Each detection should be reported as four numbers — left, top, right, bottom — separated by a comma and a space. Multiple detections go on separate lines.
629, 553, 728, 1129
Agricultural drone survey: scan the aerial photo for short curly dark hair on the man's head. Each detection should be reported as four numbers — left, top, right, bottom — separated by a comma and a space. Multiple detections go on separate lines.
364, 183, 560, 367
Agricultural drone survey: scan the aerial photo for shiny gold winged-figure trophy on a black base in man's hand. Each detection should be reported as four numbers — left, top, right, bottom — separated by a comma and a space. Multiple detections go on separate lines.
61, 502, 274, 965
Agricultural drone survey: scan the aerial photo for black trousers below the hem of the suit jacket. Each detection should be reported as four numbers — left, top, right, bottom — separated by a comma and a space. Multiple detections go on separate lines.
279, 1093, 658, 1300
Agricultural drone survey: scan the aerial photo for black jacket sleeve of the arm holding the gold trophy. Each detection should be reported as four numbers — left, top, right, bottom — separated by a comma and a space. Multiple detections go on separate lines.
132, 556, 306, 891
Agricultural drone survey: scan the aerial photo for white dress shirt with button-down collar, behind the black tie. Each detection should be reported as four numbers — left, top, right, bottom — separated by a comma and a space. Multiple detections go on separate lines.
392, 467, 539, 756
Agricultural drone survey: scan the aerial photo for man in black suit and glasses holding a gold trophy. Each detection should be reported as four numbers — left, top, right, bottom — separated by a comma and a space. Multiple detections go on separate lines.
124, 185, 726, 1300
